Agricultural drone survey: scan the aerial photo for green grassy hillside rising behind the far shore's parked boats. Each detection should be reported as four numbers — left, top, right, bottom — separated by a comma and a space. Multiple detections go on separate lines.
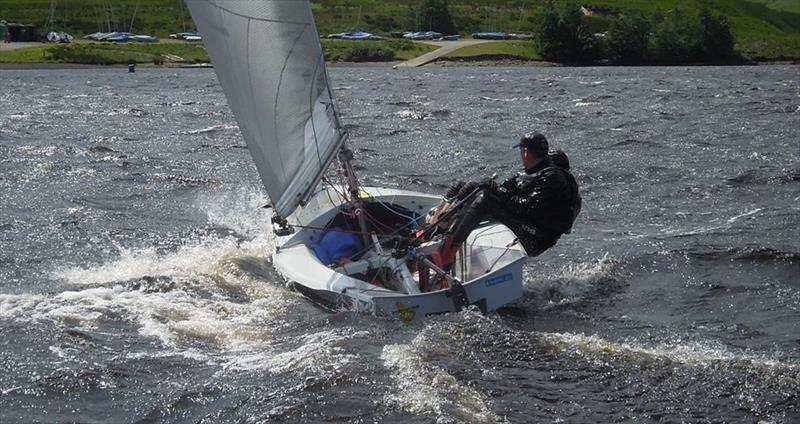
0, 0, 800, 60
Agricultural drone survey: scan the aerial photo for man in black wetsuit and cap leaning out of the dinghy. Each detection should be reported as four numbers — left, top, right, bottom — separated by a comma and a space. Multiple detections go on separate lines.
433, 133, 581, 270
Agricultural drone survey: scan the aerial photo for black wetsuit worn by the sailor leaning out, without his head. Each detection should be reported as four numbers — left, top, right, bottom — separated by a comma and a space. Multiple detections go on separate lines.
451, 157, 581, 256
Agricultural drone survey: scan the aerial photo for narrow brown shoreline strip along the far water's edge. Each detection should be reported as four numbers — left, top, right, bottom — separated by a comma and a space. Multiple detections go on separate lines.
0, 58, 800, 71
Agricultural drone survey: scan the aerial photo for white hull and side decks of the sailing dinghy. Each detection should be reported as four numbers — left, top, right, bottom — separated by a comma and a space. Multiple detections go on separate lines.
273, 188, 526, 321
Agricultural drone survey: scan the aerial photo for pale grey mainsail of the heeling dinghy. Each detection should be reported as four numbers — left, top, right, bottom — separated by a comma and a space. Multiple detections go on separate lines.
186, 0, 343, 217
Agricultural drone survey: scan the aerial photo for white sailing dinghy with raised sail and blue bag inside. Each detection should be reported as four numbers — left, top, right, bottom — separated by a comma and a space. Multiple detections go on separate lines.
186, 0, 526, 321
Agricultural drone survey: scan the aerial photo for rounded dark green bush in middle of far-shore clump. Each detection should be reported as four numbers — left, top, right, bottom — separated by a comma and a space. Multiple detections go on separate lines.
607, 14, 650, 64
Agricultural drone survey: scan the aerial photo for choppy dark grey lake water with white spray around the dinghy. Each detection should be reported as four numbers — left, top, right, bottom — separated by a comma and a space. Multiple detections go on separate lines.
0, 66, 800, 423
